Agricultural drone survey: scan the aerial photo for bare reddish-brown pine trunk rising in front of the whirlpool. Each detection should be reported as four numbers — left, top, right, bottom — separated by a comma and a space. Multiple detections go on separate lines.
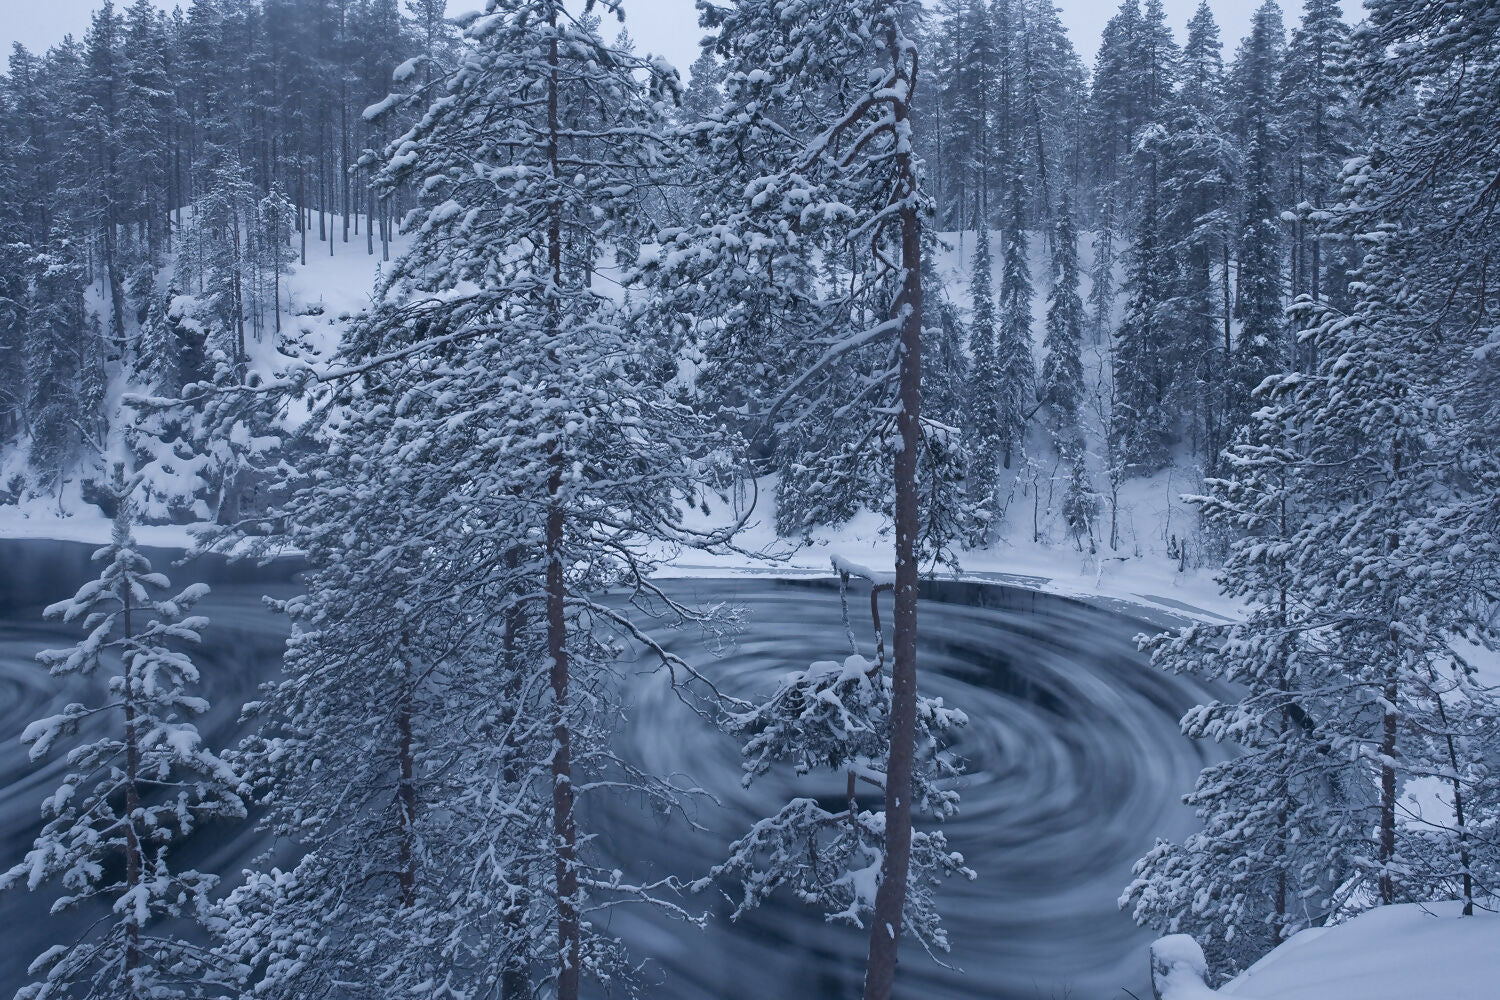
864, 25, 923, 1000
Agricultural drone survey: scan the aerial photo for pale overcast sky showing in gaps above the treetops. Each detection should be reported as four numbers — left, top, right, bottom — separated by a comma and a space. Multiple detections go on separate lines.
0, 0, 1361, 75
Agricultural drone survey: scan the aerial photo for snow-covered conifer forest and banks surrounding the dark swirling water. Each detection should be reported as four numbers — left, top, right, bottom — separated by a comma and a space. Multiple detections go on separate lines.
0, 0, 1500, 1000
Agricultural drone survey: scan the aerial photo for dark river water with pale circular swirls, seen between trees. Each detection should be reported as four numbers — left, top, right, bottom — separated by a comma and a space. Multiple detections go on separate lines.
0, 541, 1212, 1000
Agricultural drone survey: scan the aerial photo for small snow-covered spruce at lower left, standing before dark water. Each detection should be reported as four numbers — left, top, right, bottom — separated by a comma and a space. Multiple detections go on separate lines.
0, 465, 246, 1000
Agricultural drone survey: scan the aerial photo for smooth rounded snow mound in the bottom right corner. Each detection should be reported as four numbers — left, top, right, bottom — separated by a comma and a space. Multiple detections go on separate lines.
1212, 903, 1500, 1000
